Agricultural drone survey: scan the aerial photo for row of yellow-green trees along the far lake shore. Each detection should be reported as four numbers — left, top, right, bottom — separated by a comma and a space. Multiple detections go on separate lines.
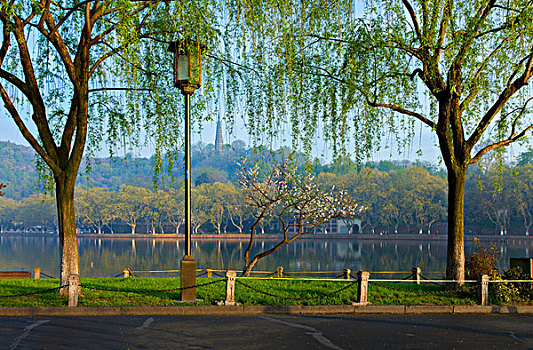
0, 162, 533, 235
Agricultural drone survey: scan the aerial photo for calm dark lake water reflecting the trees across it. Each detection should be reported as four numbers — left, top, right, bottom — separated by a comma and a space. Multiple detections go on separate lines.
0, 234, 533, 278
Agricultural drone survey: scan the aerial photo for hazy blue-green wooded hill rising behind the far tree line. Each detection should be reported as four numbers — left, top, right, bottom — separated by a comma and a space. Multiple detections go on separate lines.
0, 140, 458, 200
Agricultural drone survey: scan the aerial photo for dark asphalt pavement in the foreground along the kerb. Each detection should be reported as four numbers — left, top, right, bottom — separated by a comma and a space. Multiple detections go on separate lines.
0, 314, 533, 350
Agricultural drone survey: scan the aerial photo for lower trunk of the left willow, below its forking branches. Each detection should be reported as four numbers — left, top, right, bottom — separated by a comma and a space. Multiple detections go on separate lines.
55, 174, 80, 295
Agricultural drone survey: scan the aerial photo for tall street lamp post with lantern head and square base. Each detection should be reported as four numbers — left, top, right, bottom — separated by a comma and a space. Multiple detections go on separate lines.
168, 40, 205, 302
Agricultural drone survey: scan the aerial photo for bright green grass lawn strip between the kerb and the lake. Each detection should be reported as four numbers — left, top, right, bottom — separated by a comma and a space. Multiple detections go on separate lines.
0, 277, 475, 307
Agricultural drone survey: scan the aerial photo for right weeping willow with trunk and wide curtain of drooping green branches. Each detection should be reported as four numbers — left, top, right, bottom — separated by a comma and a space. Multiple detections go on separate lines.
216, 0, 533, 283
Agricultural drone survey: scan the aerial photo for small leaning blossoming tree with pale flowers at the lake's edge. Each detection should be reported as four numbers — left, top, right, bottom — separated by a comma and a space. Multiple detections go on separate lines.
240, 160, 364, 276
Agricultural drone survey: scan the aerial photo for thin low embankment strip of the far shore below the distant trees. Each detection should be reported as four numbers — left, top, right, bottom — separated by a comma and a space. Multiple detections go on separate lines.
0, 232, 533, 242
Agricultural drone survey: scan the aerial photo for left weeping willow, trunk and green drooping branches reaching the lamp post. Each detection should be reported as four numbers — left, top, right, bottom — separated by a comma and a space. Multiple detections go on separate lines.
0, 0, 218, 292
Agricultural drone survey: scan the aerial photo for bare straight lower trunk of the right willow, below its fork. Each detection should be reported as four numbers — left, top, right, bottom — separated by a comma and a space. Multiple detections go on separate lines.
446, 166, 468, 285
